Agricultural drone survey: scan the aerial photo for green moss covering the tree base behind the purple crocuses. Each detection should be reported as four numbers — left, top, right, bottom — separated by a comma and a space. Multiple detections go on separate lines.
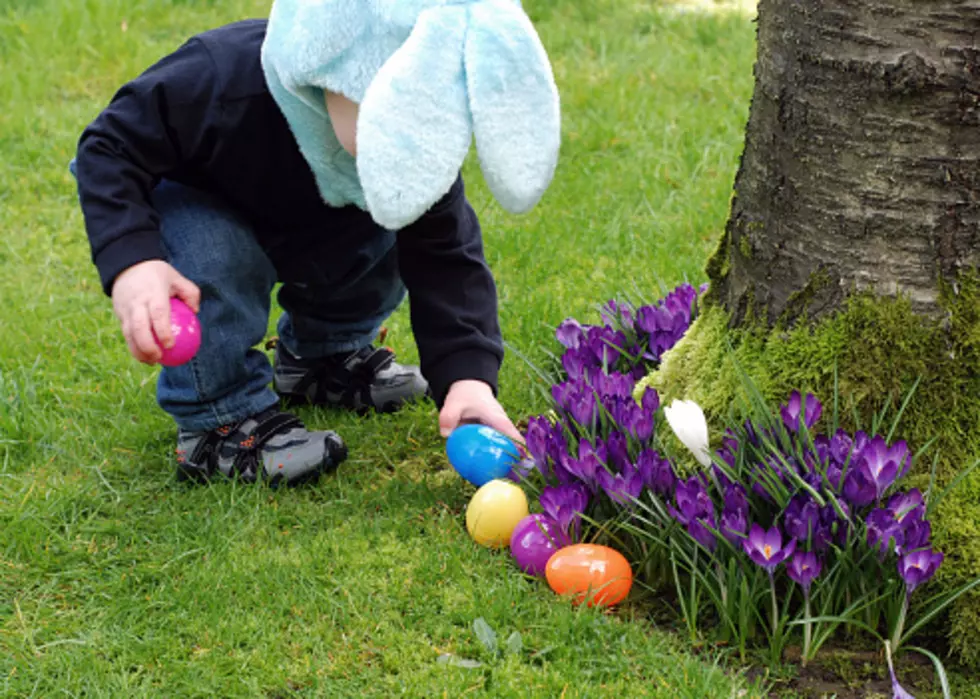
640, 272, 980, 668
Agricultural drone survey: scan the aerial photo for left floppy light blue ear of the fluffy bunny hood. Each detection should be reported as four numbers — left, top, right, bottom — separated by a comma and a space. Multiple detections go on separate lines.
357, 5, 473, 229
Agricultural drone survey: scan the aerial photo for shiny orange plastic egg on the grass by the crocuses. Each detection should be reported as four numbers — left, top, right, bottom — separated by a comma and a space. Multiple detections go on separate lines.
545, 544, 633, 607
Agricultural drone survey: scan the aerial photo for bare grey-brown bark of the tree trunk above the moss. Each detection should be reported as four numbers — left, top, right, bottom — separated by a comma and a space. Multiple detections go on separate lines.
709, 0, 980, 325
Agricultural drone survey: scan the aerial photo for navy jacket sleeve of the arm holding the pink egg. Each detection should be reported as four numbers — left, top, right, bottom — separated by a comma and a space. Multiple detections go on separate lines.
75, 39, 219, 295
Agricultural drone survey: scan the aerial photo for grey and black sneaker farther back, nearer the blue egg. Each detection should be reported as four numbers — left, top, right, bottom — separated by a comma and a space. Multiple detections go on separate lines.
272, 342, 429, 413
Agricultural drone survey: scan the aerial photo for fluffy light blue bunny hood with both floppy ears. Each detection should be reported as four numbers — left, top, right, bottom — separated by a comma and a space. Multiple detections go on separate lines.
262, 0, 561, 229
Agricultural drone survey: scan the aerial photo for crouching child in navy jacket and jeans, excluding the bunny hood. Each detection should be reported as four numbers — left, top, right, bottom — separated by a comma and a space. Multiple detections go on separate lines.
72, 0, 550, 485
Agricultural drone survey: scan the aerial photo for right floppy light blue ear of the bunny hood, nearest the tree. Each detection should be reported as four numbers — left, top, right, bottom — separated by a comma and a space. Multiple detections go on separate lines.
465, 0, 561, 213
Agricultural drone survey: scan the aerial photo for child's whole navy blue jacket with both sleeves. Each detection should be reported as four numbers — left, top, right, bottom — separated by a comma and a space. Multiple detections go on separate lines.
76, 20, 503, 405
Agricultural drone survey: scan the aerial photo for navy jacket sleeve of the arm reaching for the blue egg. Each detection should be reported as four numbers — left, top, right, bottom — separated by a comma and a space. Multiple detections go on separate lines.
398, 179, 504, 408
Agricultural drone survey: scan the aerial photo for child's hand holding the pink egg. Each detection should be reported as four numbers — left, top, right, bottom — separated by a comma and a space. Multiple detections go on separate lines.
112, 260, 201, 364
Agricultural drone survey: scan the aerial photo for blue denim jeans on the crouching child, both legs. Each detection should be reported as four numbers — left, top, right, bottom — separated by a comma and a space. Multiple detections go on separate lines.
73, 167, 406, 430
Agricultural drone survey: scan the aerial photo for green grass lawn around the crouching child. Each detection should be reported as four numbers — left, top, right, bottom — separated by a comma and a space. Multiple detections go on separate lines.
0, 0, 754, 697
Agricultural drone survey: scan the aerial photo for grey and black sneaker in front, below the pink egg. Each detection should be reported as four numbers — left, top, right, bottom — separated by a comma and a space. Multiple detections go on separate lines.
177, 408, 347, 486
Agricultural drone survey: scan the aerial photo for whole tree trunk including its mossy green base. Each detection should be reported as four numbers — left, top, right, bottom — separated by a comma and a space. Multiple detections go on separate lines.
646, 0, 980, 667
